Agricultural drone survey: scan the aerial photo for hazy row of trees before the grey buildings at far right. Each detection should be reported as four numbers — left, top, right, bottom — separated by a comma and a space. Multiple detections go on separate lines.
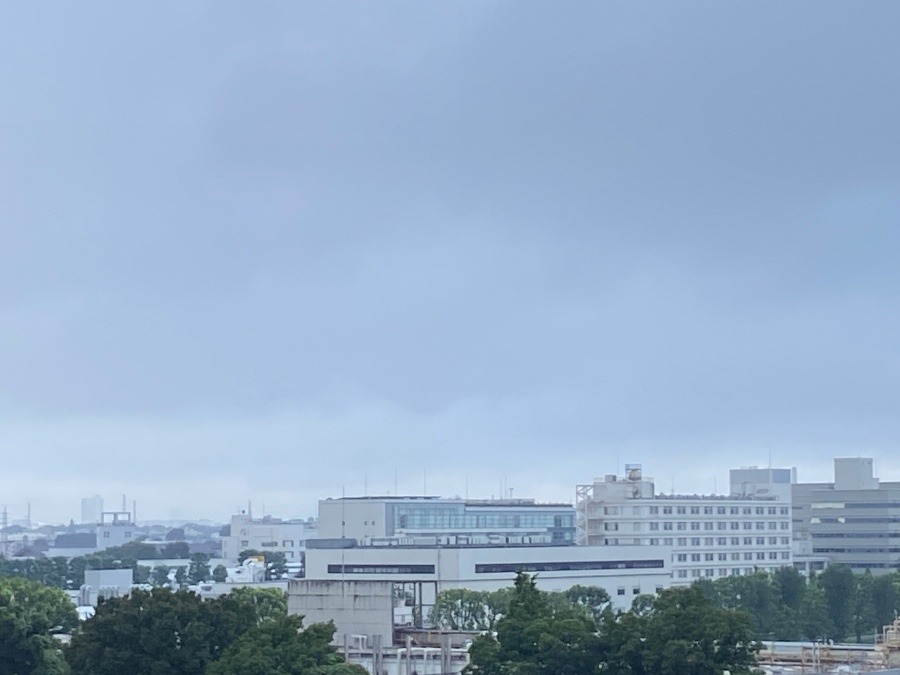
697, 565, 900, 642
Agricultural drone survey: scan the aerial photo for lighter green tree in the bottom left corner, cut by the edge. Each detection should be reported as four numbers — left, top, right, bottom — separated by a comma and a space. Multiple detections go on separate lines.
0, 578, 78, 675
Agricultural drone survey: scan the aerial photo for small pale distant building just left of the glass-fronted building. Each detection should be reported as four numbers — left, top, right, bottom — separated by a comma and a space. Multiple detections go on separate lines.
222, 513, 318, 566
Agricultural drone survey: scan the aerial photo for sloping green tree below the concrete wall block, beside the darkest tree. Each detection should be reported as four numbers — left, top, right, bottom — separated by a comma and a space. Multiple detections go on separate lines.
206, 615, 367, 675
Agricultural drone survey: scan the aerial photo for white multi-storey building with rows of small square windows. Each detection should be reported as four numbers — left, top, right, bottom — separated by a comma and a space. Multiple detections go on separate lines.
576, 464, 793, 584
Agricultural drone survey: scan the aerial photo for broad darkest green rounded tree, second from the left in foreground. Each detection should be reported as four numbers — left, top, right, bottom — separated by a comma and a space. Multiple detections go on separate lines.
66, 588, 257, 675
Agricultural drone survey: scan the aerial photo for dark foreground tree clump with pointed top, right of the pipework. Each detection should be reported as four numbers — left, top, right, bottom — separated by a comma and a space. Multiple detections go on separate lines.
460, 573, 759, 675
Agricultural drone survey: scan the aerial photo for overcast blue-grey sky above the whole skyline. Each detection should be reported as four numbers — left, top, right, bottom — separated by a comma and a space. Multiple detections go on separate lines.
0, 0, 900, 520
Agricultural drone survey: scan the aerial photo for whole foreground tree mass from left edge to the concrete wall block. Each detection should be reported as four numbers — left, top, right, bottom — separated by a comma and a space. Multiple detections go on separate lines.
0, 578, 366, 675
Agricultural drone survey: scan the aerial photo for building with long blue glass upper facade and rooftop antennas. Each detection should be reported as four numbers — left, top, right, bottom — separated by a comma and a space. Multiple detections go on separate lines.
319, 496, 575, 545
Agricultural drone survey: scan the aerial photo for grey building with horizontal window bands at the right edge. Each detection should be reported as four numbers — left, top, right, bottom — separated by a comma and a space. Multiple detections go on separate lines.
793, 457, 900, 574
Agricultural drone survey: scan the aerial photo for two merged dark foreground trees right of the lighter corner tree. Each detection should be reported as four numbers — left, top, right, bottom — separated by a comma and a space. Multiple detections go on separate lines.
66, 588, 365, 675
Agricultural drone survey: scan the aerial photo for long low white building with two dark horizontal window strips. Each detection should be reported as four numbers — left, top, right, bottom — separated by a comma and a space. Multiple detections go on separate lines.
306, 540, 671, 609
